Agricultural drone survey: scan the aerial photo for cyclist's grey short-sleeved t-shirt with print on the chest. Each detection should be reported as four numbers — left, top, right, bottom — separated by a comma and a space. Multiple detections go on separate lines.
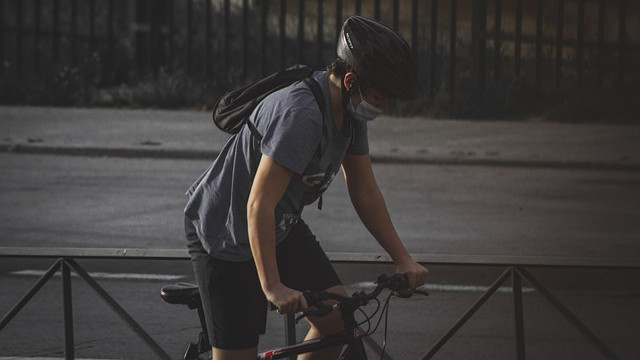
185, 72, 369, 261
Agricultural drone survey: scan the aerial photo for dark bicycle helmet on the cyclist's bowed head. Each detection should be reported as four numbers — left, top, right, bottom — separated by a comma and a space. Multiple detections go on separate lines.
337, 16, 418, 98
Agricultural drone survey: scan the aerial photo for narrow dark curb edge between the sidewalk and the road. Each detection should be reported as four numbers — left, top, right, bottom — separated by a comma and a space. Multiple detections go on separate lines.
0, 144, 640, 172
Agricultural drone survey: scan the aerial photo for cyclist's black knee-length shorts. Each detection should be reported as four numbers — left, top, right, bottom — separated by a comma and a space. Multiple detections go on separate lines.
185, 220, 342, 350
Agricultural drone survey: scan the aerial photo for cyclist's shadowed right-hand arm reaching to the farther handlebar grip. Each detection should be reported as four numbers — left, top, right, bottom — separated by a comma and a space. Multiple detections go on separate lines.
342, 154, 428, 288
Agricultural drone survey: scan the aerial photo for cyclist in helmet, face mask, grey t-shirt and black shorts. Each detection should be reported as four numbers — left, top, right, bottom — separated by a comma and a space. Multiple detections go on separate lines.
185, 16, 427, 360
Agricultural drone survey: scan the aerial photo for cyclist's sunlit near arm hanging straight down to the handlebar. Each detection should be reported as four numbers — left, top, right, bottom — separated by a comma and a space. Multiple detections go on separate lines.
247, 155, 307, 314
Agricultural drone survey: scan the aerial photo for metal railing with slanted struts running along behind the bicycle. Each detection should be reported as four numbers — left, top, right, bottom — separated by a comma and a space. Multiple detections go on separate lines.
0, 247, 640, 360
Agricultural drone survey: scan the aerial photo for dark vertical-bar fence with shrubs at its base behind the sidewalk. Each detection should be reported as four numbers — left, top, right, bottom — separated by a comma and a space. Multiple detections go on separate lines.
0, 0, 640, 116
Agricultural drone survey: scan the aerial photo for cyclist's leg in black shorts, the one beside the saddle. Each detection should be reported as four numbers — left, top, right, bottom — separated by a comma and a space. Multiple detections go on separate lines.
185, 220, 266, 360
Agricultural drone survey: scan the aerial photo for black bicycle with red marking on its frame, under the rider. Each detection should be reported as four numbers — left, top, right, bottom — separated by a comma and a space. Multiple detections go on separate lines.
160, 274, 428, 360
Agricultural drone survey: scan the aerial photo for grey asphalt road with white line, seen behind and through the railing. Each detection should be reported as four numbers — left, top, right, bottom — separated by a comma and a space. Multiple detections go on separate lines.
0, 154, 640, 359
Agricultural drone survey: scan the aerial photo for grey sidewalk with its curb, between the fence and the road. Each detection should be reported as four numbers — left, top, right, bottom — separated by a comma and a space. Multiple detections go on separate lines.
0, 107, 640, 171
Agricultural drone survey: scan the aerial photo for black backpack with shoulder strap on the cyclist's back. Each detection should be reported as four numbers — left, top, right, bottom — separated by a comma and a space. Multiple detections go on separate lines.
213, 65, 324, 141
